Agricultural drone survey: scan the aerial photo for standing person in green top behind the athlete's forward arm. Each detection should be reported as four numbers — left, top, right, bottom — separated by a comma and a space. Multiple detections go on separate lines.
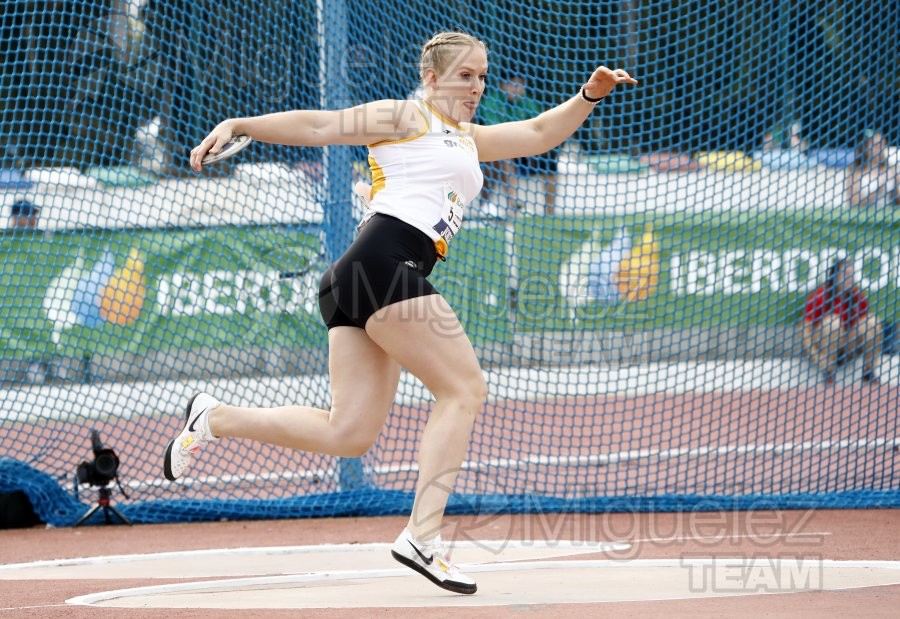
478, 73, 559, 215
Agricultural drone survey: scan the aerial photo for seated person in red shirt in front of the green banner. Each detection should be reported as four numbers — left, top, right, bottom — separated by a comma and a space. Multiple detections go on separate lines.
803, 259, 882, 384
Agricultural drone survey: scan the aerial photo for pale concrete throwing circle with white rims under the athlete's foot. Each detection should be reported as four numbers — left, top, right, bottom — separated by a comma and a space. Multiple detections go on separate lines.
0, 541, 900, 609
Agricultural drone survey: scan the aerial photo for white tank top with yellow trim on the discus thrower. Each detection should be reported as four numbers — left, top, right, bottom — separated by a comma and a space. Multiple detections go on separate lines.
363, 101, 484, 258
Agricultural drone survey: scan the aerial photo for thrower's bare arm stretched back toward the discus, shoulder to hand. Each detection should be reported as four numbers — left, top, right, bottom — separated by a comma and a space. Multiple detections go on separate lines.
191, 99, 422, 171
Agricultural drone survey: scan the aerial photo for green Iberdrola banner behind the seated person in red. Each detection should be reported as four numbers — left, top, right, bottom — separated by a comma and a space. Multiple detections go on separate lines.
515, 212, 900, 331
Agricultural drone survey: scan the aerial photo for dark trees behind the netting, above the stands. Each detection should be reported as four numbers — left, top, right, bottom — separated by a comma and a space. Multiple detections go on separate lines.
0, 0, 900, 171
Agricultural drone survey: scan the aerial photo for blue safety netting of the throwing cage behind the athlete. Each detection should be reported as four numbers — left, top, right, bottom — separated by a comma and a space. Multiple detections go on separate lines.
0, 0, 900, 525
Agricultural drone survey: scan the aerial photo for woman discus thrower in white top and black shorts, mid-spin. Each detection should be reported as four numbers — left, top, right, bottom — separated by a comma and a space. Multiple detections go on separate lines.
172, 32, 637, 593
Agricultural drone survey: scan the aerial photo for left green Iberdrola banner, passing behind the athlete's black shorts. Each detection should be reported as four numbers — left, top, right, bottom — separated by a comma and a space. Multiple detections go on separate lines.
0, 226, 509, 358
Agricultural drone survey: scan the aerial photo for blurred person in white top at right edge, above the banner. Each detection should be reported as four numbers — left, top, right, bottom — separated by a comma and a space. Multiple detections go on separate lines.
844, 130, 900, 207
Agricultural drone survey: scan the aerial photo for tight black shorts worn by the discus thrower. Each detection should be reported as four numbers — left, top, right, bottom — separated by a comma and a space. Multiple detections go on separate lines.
319, 214, 438, 329
